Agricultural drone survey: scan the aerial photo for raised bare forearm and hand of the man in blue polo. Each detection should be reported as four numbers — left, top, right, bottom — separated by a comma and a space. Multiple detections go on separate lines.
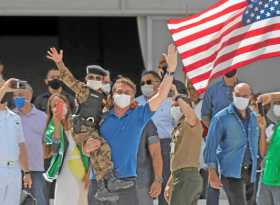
149, 44, 177, 111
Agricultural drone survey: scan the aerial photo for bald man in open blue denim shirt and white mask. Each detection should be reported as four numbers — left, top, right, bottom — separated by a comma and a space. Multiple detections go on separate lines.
204, 83, 265, 205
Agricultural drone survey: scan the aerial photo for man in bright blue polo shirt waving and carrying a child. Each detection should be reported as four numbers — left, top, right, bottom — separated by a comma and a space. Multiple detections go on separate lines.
84, 45, 177, 205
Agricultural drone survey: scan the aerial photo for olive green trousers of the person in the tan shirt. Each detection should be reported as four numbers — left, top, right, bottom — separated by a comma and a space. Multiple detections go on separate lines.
170, 168, 203, 205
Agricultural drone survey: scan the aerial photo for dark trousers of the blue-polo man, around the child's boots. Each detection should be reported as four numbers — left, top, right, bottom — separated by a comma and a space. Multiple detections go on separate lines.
88, 180, 138, 205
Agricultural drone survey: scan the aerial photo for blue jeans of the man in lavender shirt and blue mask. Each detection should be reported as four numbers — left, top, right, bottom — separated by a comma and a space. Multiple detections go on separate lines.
30, 172, 49, 205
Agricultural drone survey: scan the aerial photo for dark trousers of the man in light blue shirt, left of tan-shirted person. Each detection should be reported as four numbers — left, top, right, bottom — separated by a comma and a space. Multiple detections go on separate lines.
158, 139, 171, 205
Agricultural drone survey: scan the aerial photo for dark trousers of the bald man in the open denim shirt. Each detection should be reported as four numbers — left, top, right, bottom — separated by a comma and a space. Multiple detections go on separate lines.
222, 169, 256, 205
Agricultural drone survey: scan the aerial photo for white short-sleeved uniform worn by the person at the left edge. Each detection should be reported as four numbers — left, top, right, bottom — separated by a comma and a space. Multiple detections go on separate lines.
0, 109, 25, 205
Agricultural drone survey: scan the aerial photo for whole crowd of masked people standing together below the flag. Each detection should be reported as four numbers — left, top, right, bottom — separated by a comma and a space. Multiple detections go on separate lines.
0, 45, 280, 205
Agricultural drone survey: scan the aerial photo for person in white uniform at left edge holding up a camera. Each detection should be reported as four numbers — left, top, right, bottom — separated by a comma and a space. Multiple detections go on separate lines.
0, 79, 32, 205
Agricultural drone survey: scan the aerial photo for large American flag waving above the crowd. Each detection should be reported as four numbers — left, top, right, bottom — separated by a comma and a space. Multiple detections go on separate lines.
168, 0, 280, 93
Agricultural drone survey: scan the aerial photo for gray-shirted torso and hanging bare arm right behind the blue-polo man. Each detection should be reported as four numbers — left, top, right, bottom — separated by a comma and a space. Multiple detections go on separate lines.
136, 121, 163, 205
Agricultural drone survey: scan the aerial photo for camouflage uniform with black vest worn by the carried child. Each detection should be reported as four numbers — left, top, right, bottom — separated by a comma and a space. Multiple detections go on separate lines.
57, 63, 113, 180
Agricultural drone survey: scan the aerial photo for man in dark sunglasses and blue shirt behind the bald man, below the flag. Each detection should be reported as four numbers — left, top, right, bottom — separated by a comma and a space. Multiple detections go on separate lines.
201, 70, 238, 205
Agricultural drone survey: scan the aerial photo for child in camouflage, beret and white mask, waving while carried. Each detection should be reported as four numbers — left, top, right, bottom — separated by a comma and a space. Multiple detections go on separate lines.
47, 48, 133, 201
